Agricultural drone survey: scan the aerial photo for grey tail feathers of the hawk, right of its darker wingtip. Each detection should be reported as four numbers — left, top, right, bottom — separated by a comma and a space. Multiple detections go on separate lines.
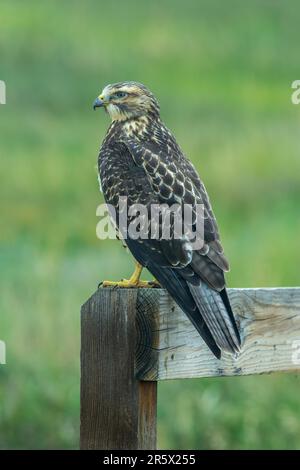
188, 281, 241, 354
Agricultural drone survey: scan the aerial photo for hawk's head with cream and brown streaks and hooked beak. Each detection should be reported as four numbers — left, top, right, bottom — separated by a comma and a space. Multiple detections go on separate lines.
93, 82, 159, 121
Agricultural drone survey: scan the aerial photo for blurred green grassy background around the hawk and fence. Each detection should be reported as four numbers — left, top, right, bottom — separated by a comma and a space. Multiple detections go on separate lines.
0, 0, 300, 449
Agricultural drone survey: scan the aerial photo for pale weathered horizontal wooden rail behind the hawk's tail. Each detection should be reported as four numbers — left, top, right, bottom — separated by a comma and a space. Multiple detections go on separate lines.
137, 288, 300, 380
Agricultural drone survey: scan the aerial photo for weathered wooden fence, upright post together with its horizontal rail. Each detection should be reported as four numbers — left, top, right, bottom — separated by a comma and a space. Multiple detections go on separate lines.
81, 288, 300, 449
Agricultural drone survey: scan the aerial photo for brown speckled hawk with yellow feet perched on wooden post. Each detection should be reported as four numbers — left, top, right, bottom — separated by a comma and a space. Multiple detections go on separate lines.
93, 82, 241, 358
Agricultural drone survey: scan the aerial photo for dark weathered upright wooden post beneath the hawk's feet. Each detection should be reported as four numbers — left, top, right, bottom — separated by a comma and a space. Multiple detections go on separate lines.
81, 289, 156, 449
